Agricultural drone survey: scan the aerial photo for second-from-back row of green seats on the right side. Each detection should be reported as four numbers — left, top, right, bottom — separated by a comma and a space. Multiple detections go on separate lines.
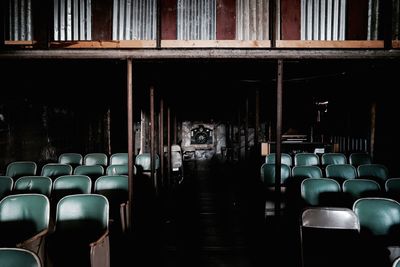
260, 163, 389, 186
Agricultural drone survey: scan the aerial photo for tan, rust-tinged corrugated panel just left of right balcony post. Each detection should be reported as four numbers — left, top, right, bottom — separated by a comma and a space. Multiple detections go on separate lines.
236, 0, 270, 40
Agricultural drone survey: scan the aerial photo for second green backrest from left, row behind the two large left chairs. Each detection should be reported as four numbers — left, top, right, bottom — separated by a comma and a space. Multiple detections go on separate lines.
13, 176, 53, 197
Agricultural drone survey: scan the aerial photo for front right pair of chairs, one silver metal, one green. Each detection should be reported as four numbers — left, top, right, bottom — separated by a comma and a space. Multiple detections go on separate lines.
300, 197, 400, 267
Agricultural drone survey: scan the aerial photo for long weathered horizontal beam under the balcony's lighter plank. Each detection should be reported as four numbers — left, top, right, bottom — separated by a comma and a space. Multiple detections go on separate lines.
0, 48, 400, 60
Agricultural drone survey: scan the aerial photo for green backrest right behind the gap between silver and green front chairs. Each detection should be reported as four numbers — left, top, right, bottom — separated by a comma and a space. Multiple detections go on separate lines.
342, 179, 381, 200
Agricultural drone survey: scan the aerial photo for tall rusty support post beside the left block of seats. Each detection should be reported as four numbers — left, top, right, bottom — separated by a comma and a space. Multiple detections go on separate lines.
126, 58, 135, 230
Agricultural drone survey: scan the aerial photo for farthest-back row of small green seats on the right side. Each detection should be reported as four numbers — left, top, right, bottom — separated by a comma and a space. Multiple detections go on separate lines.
265, 152, 372, 167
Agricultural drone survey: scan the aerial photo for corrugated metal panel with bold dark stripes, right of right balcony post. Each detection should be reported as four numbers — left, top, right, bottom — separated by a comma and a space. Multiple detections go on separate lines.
301, 0, 346, 40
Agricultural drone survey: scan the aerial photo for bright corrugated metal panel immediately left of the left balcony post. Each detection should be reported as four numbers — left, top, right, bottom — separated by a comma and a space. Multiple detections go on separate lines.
113, 0, 157, 40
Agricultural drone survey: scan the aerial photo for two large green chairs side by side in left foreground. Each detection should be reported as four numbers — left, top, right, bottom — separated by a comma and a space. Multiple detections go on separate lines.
0, 194, 110, 266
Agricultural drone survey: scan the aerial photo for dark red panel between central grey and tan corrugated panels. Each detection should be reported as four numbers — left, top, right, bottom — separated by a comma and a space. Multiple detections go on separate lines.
216, 0, 236, 40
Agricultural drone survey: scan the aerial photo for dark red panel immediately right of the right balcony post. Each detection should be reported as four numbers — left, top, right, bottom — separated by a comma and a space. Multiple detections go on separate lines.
281, 0, 301, 40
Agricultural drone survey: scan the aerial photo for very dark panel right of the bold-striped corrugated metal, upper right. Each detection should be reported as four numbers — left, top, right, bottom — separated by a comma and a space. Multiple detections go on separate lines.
346, 0, 369, 40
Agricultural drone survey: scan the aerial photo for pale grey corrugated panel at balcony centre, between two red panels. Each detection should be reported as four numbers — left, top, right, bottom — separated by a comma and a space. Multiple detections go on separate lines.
177, 0, 216, 40
